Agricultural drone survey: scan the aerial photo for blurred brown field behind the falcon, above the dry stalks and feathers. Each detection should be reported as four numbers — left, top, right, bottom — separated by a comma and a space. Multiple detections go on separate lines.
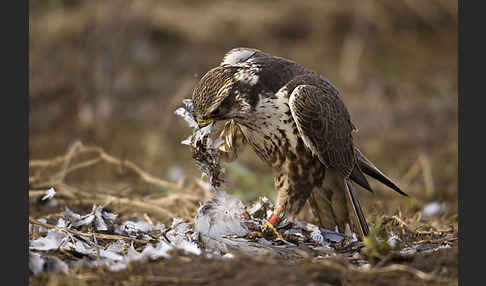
29, 0, 458, 219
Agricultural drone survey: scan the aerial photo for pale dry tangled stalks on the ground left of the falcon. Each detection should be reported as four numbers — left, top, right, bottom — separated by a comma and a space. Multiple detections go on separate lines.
29, 141, 210, 223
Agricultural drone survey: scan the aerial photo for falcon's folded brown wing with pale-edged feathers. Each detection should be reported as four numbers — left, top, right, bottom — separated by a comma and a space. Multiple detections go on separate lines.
289, 78, 356, 177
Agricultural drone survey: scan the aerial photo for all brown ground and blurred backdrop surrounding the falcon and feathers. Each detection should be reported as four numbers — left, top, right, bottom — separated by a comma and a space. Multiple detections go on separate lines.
29, 0, 458, 285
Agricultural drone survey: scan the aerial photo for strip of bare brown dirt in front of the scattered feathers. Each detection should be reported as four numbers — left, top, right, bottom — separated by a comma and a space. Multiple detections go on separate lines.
31, 248, 457, 286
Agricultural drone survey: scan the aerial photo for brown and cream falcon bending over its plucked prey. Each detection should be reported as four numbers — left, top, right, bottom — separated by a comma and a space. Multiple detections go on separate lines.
192, 48, 406, 239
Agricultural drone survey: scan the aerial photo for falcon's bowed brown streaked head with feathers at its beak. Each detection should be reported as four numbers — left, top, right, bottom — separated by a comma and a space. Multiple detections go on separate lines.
192, 65, 258, 126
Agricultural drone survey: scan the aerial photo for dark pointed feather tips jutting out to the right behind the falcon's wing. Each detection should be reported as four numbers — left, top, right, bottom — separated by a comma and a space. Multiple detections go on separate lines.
349, 147, 408, 196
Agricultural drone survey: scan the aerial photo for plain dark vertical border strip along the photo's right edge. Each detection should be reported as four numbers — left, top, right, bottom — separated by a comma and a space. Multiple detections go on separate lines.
458, 0, 486, 285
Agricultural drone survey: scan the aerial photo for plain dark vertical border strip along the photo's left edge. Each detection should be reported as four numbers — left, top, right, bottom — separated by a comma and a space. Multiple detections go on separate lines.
0, 1, 29, 285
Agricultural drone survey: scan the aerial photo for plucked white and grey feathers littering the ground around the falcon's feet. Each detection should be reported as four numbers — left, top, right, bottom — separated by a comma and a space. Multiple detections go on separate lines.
29, 190, 450, 275
